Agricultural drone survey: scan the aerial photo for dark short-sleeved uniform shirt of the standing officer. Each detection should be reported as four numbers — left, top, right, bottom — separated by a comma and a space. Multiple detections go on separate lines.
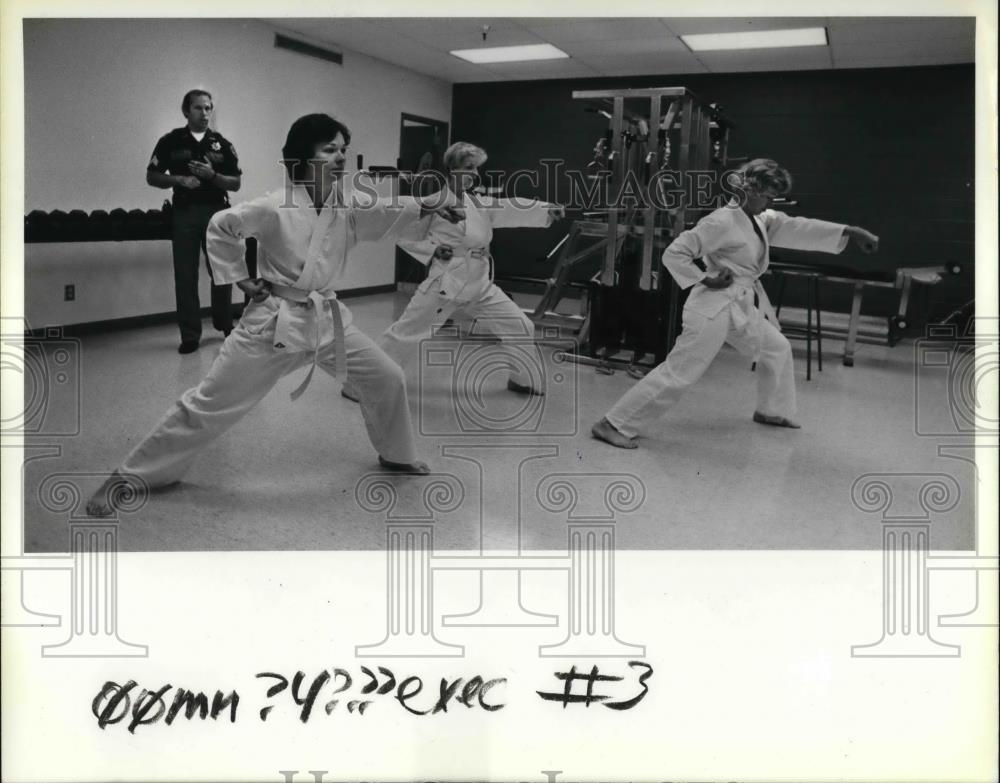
146, 125, 243, 207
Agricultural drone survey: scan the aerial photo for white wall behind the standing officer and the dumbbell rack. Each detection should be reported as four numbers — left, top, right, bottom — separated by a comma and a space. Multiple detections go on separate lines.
24, 19, 451, 328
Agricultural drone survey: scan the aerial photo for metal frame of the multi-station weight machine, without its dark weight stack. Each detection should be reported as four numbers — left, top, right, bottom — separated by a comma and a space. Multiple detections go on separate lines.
529, 87, 735, 368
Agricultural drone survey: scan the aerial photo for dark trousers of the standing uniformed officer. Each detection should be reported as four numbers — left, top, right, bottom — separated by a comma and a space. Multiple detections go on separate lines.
172, 204, 233, 342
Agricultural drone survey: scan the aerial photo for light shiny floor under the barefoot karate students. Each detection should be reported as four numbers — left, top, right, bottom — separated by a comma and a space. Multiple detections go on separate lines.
24, 294, 974, 552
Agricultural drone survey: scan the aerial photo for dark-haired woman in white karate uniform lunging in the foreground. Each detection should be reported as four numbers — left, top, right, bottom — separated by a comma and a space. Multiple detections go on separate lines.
88, 114, 461, 516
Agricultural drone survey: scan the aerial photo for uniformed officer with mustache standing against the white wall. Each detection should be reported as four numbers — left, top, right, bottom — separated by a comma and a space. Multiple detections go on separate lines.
146, 90, 243, 353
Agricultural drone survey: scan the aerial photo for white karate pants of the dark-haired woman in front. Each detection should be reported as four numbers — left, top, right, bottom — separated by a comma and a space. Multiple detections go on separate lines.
119, 316, 417, 487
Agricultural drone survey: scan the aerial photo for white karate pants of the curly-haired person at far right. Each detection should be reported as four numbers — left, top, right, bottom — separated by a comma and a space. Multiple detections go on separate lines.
605, 307, 795, 438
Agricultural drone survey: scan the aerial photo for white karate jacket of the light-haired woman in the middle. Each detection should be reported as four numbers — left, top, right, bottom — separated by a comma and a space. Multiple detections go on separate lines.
397, 193, 552, 302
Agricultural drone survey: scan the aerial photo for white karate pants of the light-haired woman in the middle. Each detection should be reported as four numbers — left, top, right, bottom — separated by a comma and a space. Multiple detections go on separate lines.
376, 281, 535, 388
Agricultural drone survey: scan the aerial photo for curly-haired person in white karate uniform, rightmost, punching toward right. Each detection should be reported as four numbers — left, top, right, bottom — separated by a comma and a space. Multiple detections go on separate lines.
591, 158, 878, 449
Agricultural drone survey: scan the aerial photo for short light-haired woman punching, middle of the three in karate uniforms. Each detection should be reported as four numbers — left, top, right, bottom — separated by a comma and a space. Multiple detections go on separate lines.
343, 141, 564, 401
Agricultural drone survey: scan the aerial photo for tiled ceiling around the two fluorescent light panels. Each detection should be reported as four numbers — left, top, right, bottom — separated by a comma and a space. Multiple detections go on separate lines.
262, 17, 975, 82
